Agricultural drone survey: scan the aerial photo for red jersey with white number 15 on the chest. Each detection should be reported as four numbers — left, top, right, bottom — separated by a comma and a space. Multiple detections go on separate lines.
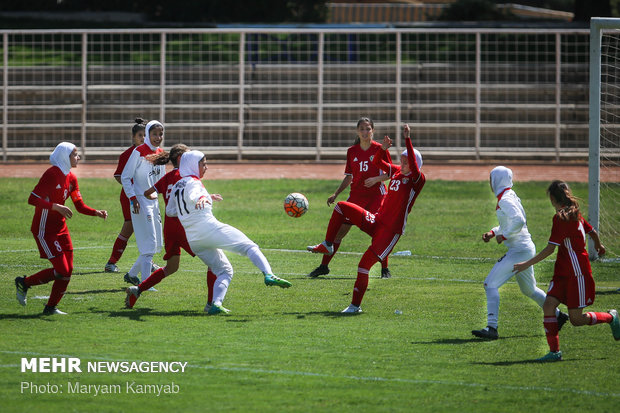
344, 141, 391, 197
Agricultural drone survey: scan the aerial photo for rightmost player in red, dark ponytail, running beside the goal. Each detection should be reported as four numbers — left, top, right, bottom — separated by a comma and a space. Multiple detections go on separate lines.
514, 181, 620, 362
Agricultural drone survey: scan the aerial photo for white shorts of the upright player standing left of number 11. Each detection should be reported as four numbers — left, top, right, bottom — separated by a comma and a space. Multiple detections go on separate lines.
131, 195, 163, 254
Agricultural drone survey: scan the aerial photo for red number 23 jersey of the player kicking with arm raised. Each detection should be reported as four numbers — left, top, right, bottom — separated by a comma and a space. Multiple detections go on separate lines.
373, 138, 426, 234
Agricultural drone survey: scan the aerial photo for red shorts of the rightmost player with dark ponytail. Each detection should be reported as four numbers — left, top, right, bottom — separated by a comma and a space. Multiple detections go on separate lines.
547, 274, 596, 309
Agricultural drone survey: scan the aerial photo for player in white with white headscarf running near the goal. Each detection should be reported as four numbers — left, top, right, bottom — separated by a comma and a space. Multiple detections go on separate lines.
472, 166, 568, 340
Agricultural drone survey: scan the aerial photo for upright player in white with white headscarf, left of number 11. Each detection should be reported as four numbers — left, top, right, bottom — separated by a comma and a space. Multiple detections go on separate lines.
121, 120, 166, 285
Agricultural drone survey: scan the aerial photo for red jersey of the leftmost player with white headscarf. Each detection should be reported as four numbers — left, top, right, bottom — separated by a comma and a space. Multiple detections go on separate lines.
28, 166, 82, 236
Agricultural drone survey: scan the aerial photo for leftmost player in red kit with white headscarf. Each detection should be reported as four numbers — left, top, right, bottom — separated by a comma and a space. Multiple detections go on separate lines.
15, 142, 108, 315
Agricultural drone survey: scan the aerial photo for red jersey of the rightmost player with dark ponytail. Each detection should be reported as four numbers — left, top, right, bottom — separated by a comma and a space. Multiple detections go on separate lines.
549, 215, 592, 276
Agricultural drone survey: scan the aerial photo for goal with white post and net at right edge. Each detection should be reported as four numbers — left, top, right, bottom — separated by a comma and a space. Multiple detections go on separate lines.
588, 18, 620, 260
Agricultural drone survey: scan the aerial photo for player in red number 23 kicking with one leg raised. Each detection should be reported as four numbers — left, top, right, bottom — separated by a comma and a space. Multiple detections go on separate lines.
308, 125, 426, 313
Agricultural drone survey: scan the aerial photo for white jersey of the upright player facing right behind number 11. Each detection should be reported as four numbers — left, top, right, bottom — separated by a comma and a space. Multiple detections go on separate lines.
121, 144, 166, 198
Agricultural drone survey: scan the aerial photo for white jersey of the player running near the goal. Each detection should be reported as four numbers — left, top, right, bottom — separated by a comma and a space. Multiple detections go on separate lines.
492, 189, 534, 250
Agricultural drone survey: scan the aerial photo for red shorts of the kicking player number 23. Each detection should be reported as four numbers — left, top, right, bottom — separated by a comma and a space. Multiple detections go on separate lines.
338, 202, 401, 261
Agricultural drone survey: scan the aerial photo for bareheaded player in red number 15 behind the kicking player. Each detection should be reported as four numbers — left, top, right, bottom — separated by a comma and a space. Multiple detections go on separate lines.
308, 117, 391, 278
